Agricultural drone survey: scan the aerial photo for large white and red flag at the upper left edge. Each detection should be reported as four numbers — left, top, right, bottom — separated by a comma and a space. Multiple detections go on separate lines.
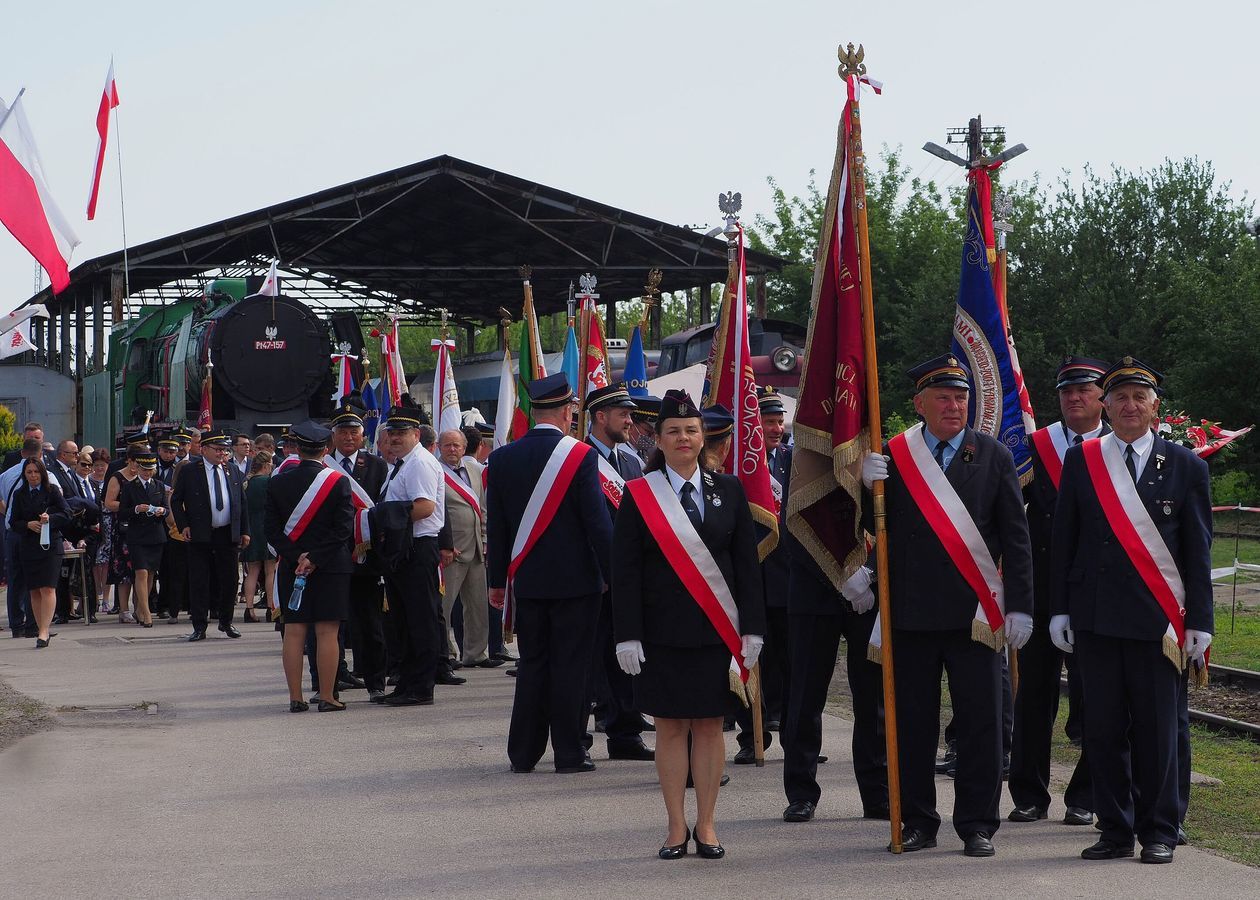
0, 93, 79, 294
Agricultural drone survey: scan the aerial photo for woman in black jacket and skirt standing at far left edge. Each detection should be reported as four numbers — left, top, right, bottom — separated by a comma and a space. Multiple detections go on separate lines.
9, 459, 69, 640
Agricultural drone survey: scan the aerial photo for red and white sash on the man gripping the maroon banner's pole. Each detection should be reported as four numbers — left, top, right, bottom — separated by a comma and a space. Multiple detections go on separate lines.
888, 422, 1005, 650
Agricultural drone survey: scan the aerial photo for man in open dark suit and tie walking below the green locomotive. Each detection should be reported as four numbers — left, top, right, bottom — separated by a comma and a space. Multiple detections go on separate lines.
170, 431, 249, 642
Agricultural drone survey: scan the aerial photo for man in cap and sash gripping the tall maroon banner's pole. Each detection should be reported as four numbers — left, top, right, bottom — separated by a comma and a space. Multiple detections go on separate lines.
862, 354, 1032, 856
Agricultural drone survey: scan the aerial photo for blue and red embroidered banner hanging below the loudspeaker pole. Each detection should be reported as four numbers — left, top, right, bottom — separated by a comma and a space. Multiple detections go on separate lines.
951, 176, 1037, 484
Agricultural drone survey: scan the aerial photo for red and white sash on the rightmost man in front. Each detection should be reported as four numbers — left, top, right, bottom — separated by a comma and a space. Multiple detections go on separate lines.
1081, 434, 1186, 669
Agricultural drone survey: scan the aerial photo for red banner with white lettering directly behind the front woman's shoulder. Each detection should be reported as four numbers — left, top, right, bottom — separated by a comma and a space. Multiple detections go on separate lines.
700, 227, 779, 560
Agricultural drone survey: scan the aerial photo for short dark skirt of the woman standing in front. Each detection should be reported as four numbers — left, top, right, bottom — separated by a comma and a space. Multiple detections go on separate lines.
633, 642, 731, 718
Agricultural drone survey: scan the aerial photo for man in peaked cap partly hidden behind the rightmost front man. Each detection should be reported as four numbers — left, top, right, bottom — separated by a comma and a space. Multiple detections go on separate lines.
1007, 357, 1111, 826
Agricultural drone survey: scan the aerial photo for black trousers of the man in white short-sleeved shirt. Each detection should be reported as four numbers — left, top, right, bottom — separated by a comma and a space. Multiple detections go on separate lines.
386, 537, 446, 697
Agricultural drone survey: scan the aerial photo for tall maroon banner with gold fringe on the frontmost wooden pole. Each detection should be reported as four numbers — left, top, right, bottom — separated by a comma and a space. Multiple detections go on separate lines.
788, 78, 871, 590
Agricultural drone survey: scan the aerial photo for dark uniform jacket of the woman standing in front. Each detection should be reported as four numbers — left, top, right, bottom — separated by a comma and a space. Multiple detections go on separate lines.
612, 471, 766, 647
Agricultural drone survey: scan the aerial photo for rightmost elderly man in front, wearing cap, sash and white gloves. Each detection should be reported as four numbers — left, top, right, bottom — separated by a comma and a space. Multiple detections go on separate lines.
1050, 357, 1213, 863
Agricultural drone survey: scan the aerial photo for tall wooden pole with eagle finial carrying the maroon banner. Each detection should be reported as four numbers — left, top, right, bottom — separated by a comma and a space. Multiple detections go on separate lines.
838, 44, 902, 853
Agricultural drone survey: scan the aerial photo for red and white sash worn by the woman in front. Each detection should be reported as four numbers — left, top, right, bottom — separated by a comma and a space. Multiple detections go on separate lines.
626, 470, 748, 682
